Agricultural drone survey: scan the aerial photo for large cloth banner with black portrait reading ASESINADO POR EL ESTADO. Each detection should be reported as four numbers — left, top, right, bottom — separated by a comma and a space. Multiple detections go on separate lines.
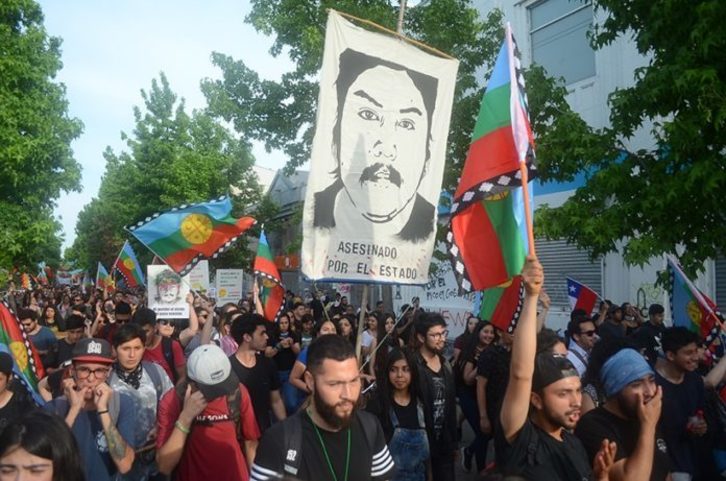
302, 11, 458, 284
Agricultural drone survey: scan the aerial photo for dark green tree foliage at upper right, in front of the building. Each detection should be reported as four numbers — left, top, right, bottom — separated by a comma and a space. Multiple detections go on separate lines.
538, 0, 726, 273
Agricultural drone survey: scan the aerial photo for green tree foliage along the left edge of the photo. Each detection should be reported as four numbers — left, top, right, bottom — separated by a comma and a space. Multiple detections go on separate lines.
0, 0, 82, 274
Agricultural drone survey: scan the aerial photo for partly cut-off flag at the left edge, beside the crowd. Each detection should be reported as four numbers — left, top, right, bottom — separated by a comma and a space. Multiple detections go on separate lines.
0, 301, 45, 406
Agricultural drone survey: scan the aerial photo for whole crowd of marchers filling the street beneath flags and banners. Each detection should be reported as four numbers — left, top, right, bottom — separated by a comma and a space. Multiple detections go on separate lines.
0, 258, 726, 481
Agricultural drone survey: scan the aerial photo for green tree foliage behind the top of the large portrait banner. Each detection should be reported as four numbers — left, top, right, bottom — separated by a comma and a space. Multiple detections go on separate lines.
202, 0, 503, 193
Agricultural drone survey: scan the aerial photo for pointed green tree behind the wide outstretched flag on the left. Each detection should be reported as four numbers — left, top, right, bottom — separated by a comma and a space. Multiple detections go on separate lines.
66, 74, 260, 268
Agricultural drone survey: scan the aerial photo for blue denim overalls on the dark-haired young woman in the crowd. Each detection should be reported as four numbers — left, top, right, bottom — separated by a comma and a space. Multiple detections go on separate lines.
388, 402, 429, 481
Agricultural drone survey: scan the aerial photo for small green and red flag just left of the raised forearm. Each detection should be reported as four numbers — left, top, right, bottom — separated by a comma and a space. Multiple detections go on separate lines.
479, 275, 524, 333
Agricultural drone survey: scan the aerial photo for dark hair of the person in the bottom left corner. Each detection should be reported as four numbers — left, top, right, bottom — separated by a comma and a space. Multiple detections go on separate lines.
0, 410, 86, 481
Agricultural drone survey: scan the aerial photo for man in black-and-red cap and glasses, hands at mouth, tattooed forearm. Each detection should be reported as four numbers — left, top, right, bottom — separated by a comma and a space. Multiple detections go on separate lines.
45, 339, 135, 481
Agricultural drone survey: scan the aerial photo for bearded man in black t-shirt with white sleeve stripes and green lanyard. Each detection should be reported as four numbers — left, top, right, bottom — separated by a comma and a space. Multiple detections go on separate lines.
250, 335, 394, 481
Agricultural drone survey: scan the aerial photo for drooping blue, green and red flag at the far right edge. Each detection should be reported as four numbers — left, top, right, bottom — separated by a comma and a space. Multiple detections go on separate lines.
667, 255, 723, 347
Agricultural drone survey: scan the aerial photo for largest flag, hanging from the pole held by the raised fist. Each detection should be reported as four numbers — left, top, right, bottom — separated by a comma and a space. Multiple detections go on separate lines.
446, 25, 535, 292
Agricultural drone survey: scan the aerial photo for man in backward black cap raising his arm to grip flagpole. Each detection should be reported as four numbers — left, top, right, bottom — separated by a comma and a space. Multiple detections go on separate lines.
495, 256, 615, 481
